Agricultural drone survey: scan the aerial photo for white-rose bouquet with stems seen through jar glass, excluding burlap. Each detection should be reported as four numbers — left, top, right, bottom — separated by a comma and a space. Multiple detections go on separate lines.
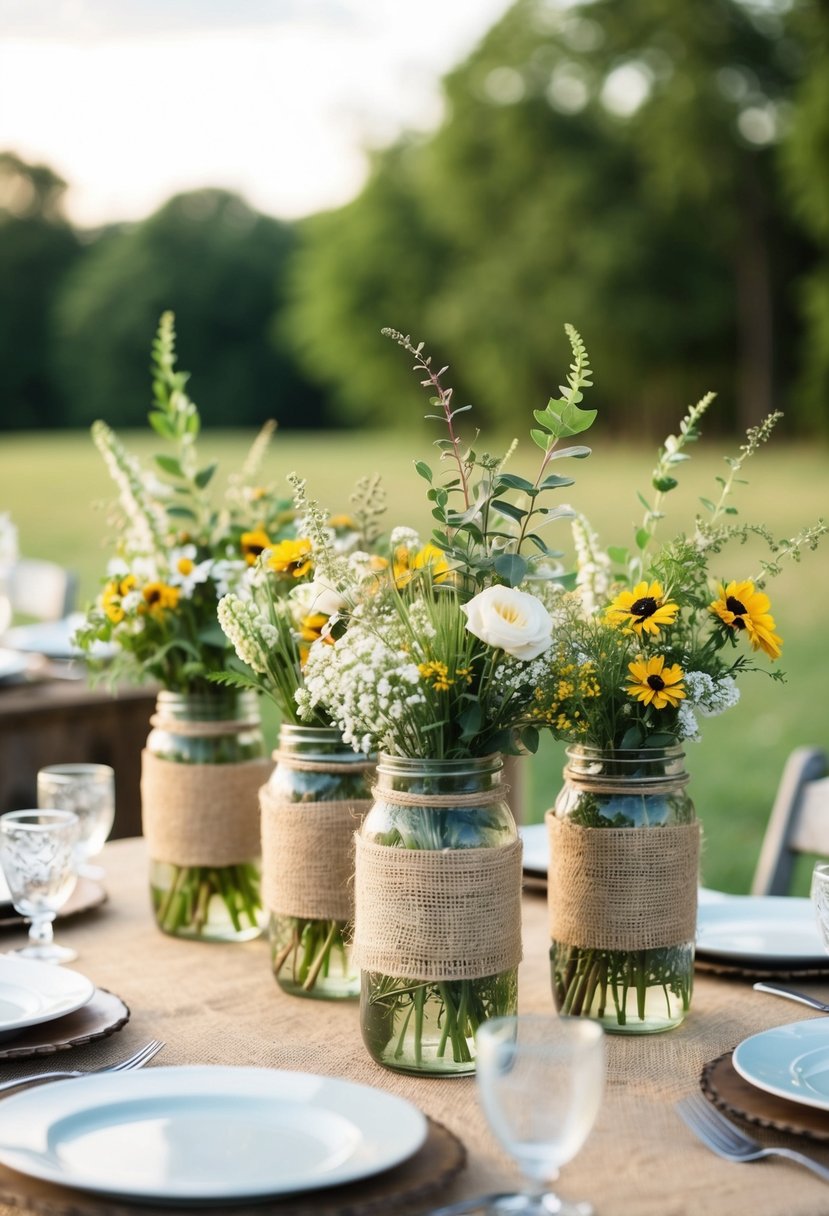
297, 326, 596, 1071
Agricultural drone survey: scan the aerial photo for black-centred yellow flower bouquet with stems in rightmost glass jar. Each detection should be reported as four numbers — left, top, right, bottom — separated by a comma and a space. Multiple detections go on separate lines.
539, 394, 825, 1030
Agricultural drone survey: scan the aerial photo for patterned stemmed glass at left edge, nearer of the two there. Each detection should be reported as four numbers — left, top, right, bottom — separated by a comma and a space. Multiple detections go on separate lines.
0, 810, 78, 963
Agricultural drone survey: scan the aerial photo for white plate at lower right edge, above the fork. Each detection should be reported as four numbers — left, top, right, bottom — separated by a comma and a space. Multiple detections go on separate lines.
732, 1017, 829, 1110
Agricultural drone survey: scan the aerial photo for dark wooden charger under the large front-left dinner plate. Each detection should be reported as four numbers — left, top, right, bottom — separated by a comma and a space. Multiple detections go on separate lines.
0, 1119, 467, 1216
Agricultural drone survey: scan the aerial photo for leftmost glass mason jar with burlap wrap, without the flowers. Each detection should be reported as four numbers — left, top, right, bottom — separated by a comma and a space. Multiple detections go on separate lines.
141, 687, 272, 941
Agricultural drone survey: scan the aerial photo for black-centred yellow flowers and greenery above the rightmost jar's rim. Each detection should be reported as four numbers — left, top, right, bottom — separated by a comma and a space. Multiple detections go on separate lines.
520, 394, 825, 750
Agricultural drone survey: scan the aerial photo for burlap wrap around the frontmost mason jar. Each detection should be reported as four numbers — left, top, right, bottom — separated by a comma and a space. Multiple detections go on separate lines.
353, 837, 521, 980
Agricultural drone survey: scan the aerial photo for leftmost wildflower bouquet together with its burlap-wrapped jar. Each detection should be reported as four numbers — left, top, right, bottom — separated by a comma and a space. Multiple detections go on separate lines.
77, 313, 294, 938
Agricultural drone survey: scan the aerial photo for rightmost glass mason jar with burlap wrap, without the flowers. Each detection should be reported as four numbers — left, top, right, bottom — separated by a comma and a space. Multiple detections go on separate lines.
547, 745, 699, 1034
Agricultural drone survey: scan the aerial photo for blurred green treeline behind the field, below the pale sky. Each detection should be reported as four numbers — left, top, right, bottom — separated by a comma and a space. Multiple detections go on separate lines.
0, 0, 829, 434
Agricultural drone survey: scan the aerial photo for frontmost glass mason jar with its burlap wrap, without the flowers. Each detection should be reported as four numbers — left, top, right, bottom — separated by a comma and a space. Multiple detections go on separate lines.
355, 754, 521, 1076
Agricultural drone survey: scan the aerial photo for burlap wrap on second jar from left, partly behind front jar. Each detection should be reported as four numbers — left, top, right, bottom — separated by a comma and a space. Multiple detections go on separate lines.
259, 786, 372, 921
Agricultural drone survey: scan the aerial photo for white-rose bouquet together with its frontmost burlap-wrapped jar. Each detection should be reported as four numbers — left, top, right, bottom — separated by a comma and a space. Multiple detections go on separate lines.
297, 327, 596, 1073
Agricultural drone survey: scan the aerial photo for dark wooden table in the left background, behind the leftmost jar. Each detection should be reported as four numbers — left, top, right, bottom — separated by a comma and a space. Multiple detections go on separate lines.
0, 679, 156, 838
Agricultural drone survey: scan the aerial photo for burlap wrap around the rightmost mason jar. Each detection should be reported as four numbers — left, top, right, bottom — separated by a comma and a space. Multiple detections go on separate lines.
546, 811, 700, 950
